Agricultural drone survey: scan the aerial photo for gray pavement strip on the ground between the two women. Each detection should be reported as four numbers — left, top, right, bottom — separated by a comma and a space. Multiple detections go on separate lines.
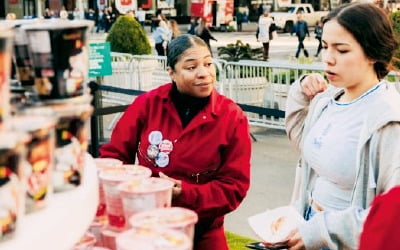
225, 127, 299, 240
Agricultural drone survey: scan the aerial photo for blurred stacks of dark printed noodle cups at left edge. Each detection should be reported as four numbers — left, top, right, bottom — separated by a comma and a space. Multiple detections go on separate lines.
0, 20, 93, 244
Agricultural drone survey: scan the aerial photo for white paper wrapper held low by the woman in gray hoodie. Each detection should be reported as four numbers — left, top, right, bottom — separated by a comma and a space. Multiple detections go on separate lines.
248, 206, 304, 244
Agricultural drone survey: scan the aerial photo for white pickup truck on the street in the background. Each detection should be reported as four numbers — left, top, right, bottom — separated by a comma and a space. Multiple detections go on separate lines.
271, 4, 328, 32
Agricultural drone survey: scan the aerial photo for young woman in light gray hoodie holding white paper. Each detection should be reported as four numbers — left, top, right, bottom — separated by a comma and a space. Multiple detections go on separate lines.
286, 3, 400, 250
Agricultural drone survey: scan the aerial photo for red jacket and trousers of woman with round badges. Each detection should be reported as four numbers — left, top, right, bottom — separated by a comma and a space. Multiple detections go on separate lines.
100, 84, 251, 249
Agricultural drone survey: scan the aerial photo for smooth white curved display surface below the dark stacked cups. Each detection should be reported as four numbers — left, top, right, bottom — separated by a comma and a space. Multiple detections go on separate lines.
0, 154, 98, 250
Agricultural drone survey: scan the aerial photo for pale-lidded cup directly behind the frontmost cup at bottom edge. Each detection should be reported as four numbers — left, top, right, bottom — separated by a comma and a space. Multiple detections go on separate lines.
129, 207, 198, 241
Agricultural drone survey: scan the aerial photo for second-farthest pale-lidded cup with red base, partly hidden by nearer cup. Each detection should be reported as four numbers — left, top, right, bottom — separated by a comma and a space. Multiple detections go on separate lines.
100, 165, 151, 230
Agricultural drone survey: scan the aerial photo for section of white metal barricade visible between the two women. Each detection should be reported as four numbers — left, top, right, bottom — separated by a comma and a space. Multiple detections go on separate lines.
222, 60, 323, 129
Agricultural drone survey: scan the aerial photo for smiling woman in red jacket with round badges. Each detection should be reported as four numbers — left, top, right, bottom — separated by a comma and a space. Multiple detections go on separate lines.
100, 35, 251, 250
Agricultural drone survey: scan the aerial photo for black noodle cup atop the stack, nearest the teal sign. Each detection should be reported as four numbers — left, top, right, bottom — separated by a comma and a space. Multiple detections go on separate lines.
22, 19, 93, 100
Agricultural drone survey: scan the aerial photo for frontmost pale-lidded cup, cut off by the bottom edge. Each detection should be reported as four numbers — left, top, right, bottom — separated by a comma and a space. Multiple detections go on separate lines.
117, 228, 193, 250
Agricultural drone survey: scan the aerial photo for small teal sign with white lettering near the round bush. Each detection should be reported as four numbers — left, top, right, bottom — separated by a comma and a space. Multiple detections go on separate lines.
89, 42, 112, 77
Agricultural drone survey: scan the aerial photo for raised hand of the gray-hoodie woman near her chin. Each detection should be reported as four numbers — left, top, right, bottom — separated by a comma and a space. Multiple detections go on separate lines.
300, 73, 328, 100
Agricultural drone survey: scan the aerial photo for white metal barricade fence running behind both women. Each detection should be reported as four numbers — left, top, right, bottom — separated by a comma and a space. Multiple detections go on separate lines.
97, 53, 400, 129
